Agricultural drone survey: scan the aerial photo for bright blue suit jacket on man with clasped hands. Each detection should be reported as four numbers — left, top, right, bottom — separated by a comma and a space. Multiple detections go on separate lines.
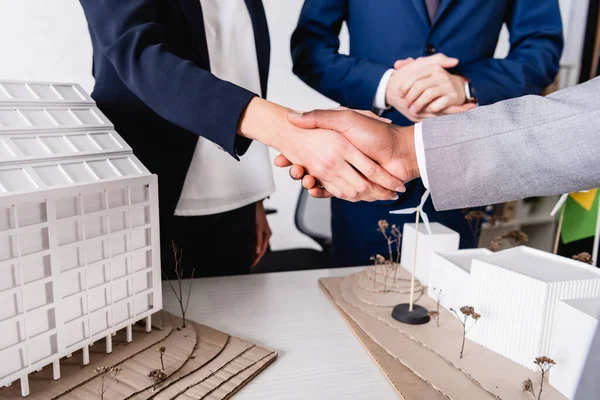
292, 0, 563, 125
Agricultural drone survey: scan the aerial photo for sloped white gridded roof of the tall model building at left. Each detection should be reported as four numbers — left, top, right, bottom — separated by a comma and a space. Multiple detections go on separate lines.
0, 81, 149, 195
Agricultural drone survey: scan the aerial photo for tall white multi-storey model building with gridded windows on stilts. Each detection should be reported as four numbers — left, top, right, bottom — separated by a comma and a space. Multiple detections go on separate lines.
0, 82, 162, 396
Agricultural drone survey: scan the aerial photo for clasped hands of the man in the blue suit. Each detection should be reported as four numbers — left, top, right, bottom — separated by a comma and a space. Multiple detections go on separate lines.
386, 53, 475, 122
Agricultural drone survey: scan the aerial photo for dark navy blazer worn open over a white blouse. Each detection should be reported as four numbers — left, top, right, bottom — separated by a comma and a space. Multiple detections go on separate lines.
81, 0, 270, 219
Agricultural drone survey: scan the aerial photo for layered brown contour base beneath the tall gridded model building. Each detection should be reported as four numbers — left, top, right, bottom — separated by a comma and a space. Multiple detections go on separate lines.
0, 312, 277, 400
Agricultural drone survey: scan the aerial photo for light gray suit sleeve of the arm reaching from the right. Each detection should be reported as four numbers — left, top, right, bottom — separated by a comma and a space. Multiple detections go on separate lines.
423, 78, 600, 210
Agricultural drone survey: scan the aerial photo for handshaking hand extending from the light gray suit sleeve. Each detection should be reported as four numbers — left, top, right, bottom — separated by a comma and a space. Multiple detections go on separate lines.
275, 110, 419, 197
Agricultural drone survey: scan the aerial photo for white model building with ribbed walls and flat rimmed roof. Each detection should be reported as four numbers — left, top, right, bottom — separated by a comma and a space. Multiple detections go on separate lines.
467, 246, 600, 369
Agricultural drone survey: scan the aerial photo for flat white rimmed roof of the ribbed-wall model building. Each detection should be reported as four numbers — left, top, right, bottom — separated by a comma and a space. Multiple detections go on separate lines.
479, 246, 600, 282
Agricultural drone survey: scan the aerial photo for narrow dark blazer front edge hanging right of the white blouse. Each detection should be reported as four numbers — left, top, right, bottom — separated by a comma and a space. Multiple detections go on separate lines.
245, 0, 271, 98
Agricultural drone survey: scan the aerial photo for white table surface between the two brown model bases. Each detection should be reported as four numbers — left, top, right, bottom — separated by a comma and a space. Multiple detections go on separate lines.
163, 268, 399, 400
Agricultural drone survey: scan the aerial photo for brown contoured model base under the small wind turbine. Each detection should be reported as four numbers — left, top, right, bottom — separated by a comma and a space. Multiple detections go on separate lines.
319, 269, 566, 400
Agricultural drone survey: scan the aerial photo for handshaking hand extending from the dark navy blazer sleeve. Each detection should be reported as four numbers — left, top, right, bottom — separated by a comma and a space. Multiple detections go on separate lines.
239, 98, 405, 201
